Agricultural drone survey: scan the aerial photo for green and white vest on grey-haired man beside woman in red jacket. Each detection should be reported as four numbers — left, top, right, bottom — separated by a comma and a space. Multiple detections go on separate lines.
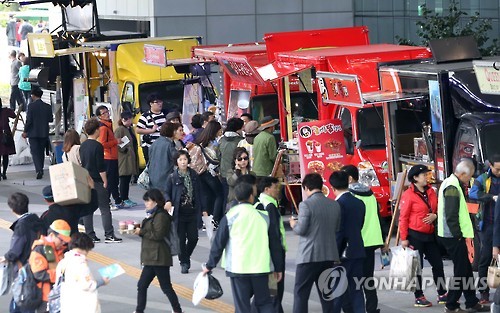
438, 174, 474, 238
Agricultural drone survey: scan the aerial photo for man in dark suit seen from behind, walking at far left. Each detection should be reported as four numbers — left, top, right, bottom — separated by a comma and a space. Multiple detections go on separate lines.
23, 87, 53, 179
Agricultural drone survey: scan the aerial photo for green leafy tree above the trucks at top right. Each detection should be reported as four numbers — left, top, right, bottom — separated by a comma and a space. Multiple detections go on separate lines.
396, 0, 500, 55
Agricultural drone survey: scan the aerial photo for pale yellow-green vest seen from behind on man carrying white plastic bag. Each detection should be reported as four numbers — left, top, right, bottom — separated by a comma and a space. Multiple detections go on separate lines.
222, 203, 274, 274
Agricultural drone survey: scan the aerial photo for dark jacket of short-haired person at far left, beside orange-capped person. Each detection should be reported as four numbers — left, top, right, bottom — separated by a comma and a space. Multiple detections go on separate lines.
5, 213, 46, 265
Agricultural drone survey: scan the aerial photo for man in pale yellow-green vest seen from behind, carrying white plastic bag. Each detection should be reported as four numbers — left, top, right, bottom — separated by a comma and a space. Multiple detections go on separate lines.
203, 182, 284, 313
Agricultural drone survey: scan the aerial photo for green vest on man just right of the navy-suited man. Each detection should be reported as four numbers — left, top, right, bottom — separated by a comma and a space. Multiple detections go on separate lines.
353, 194, 384, 247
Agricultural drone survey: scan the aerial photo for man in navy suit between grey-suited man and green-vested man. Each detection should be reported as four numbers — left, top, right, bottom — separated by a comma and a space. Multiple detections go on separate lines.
329, 171, 365, 313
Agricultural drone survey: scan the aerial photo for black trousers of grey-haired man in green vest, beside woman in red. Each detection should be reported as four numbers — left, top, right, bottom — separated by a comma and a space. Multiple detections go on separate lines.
438, 237, 479, 310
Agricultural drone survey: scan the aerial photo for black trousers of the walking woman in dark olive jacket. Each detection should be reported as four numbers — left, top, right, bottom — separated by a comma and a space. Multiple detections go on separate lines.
135, 265, 182, 313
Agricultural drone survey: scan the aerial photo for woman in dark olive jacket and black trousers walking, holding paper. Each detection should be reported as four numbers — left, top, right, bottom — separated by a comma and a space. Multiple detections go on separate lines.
134, 189, 182, 313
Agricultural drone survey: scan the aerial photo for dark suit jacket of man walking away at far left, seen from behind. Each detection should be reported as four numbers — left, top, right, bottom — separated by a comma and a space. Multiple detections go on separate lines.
24, 99, 53, 138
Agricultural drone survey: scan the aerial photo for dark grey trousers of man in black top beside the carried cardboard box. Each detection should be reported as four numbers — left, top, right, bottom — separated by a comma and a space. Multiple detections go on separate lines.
83, 182, 115, 237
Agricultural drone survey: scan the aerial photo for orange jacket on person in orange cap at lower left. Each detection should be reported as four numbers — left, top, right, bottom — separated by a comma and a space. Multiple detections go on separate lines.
28, 236, 64, 301
